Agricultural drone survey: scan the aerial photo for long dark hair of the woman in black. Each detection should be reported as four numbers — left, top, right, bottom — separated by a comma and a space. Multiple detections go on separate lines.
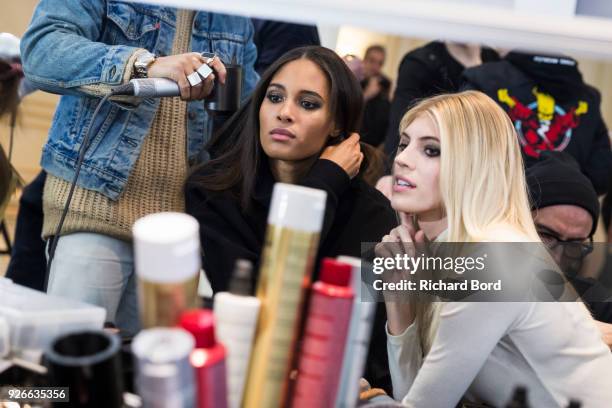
187, 46, 365, 210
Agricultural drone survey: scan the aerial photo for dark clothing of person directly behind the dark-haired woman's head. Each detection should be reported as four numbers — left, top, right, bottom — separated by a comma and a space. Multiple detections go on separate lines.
251, 18, 321, 75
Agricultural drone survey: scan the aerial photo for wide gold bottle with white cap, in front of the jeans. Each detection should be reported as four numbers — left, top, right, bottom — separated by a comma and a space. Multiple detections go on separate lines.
133, 212, 201, 328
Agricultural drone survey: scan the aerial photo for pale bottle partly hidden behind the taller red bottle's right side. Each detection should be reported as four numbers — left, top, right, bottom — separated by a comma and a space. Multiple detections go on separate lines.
335, 256, 376, 408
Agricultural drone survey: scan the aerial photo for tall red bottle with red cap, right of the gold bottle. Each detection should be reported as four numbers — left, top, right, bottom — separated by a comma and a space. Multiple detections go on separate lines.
291, 258, 354, 408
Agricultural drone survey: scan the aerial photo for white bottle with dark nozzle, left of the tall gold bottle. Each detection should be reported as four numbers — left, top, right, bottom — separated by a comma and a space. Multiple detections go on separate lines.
213, 259, 261, 408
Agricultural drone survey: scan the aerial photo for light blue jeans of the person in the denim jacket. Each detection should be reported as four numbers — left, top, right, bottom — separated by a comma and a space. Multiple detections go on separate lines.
47, 232, 140, 336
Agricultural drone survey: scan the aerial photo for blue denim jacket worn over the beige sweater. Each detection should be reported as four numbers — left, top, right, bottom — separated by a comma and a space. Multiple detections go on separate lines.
21, 0, 259, 200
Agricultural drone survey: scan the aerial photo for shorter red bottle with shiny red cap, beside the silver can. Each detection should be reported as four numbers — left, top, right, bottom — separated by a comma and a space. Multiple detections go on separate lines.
180, 309, 227, 408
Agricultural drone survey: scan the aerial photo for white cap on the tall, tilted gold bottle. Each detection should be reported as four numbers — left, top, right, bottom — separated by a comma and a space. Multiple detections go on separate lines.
268, 183, 327, 232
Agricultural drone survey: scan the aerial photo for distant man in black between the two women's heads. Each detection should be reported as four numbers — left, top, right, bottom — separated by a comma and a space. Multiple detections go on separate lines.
360, 45, 391, 147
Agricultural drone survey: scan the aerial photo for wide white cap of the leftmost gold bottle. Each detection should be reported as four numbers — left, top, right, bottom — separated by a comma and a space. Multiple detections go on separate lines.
133, 212, 201, 283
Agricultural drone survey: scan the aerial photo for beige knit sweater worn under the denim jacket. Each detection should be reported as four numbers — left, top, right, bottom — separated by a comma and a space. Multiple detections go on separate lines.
43, 10, 194, 241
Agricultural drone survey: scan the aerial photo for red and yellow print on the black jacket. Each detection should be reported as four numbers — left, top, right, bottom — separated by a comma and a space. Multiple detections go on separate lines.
497, 87, 589, 158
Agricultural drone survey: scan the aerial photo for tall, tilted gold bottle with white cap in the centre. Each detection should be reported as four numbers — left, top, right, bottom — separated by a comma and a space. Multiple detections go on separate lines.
244, 183, 327, 408
